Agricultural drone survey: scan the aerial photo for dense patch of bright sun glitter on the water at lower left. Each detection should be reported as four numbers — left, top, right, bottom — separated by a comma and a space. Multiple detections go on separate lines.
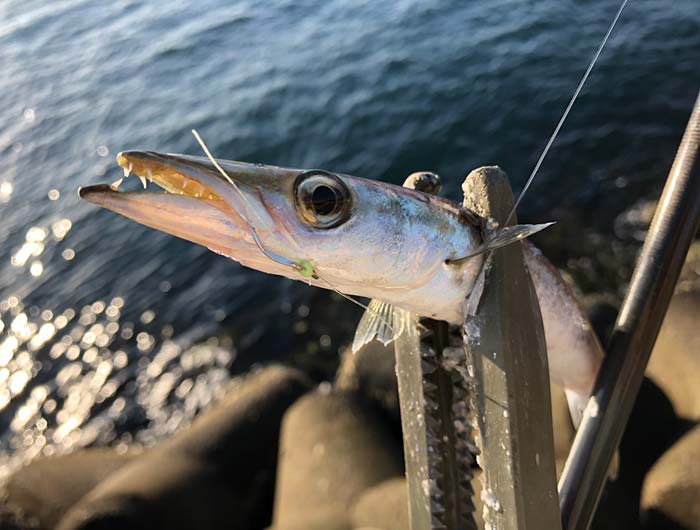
0, 292, 235, 479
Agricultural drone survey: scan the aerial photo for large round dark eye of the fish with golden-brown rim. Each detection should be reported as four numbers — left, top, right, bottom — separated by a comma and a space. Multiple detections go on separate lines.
294, 170, 352, 228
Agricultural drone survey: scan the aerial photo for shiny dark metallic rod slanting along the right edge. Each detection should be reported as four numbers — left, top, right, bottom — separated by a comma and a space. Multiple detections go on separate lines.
559, 94, 700, 530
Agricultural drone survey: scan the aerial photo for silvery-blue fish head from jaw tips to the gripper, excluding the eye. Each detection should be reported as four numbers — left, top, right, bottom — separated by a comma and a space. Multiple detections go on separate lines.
81, 151, 481, 323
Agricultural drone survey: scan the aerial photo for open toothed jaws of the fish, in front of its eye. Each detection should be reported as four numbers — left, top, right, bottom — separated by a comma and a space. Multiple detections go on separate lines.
79, 151, 297, 274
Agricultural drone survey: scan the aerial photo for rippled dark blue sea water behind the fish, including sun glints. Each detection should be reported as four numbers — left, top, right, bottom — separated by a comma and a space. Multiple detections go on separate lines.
0, 0, 700, 474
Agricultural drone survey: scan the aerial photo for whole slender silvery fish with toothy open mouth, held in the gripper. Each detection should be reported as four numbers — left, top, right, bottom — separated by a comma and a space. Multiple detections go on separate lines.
80, 151, 602, 423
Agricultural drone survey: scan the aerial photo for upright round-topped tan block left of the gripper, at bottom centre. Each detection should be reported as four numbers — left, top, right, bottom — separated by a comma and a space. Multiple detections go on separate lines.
274, 389, 403, 530
